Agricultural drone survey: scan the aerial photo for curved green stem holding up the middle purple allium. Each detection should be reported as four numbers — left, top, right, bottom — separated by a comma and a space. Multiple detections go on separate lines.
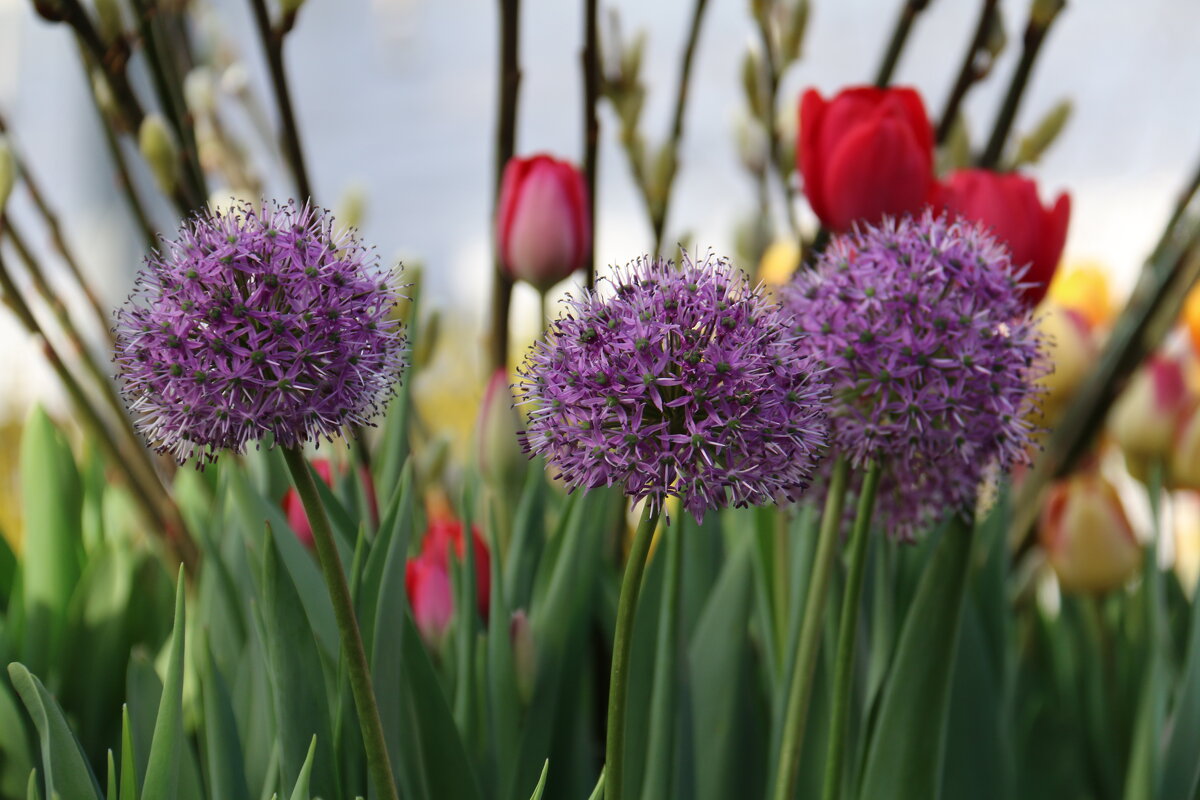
605, 509, 659, 800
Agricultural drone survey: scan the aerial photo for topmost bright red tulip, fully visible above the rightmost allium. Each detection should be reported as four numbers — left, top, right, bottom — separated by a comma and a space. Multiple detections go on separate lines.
797, 86, 934, 233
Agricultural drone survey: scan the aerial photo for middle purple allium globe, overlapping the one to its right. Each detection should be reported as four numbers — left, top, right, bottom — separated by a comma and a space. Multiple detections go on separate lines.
516, 254, 827, 521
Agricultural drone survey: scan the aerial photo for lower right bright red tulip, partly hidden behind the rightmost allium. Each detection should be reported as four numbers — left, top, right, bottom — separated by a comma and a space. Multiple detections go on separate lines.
936, 169, 1070, 307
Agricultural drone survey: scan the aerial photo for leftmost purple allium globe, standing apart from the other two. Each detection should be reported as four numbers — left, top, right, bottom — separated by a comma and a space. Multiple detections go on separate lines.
114, 203, 404, 464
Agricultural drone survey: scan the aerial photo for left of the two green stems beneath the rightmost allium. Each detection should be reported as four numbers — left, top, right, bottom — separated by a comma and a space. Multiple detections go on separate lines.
774, 457, 850, 800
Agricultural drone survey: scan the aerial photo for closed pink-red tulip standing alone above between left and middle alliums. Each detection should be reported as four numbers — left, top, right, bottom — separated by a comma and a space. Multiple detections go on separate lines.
496, 155, 592, 290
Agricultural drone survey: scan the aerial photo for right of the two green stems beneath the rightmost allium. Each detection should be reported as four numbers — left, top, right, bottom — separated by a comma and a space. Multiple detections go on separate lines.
822, 463, 881, 800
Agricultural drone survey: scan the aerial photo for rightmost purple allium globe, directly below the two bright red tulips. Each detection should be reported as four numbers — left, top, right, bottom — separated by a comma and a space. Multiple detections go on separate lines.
784, 212, 1045, 537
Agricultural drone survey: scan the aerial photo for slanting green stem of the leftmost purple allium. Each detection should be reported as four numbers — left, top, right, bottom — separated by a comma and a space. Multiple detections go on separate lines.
283, 447, 398, 800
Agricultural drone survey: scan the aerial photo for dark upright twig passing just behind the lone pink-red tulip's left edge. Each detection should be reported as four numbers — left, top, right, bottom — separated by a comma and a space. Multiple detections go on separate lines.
491, 0, 521, 368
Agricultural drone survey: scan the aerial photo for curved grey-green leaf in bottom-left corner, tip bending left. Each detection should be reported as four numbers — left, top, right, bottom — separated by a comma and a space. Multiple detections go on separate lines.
8, 663, 101, 800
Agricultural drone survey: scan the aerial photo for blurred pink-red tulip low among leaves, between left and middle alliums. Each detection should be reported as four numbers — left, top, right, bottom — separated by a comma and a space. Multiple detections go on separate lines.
404, 517, 492, 645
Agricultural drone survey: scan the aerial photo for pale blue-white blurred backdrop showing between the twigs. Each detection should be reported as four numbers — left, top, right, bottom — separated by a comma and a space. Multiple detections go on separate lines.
0, 0, 1200, 419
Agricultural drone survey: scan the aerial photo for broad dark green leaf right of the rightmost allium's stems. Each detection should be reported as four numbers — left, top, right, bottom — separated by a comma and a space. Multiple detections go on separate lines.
858, 516, 974, 800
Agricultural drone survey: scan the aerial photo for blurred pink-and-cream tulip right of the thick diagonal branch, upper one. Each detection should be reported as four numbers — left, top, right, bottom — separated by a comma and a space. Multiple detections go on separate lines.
1109, 355, 1189, 465
